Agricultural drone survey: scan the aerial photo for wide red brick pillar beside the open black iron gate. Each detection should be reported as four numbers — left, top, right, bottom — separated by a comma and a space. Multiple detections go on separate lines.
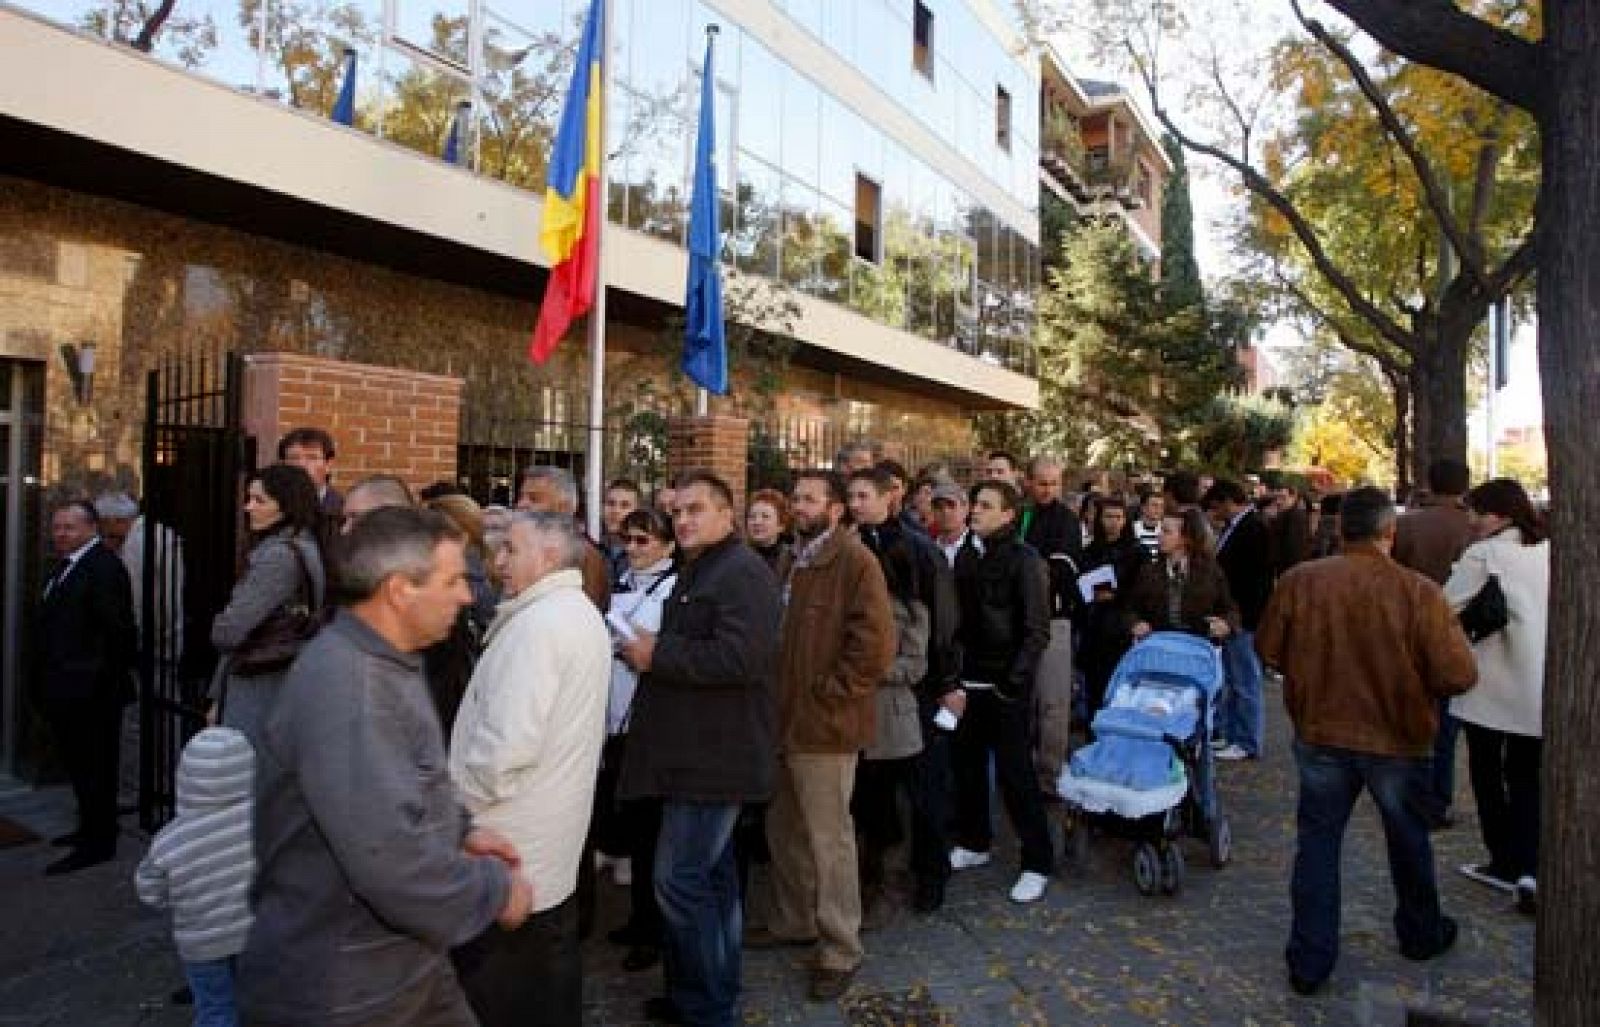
245, 354, 462, 490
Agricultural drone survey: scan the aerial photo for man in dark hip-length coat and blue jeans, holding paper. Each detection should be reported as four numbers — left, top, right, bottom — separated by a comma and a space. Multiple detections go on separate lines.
618, 472, 779, 1027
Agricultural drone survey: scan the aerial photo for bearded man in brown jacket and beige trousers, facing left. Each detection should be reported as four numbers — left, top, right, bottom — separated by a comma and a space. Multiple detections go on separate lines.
750, 470, 896, 1001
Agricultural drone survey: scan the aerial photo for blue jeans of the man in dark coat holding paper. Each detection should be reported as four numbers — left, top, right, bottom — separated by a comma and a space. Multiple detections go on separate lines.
656, 800, 744, 1027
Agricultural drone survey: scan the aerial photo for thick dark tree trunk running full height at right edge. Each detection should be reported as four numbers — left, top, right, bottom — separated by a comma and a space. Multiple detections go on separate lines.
1534, 0, 1600, 1027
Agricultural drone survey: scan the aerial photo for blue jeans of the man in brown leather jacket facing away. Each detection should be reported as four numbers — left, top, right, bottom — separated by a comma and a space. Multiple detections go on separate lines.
1285, 741, 1443, 981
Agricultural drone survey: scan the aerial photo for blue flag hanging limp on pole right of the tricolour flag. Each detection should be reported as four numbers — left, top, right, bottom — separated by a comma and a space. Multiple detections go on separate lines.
683, 28, 728, 395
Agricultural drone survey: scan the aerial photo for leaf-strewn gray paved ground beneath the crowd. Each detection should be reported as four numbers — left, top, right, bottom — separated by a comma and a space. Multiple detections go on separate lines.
0, 678, 1533, 1027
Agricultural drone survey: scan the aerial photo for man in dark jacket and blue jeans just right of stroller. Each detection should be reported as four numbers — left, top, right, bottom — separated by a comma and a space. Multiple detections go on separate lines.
1200, 480, 1272, 760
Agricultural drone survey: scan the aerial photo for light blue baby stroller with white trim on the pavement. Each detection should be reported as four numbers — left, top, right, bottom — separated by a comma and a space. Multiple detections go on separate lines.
1056, 632, 1234, 896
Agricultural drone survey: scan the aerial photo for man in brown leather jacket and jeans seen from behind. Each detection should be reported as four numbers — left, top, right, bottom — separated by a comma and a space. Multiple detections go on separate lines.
1256, 488, 1478, 995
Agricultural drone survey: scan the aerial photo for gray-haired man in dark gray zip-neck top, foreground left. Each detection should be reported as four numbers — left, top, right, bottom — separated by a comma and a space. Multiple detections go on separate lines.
238, 507, 533, 1027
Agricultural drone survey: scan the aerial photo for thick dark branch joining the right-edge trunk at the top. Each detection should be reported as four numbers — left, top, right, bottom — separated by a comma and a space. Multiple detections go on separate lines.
1328, 0, 1546, 115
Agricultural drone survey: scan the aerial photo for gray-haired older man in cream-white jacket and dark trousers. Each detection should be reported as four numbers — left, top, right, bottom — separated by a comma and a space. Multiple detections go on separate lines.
450, 514, 611, 1027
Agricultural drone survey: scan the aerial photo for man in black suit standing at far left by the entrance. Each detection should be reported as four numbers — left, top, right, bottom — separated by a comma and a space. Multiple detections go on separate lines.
38, 499, 138, 877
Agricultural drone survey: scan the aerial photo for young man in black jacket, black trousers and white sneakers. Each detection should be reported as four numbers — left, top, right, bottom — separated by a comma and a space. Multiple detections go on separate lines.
950, 482, 1053, 902
